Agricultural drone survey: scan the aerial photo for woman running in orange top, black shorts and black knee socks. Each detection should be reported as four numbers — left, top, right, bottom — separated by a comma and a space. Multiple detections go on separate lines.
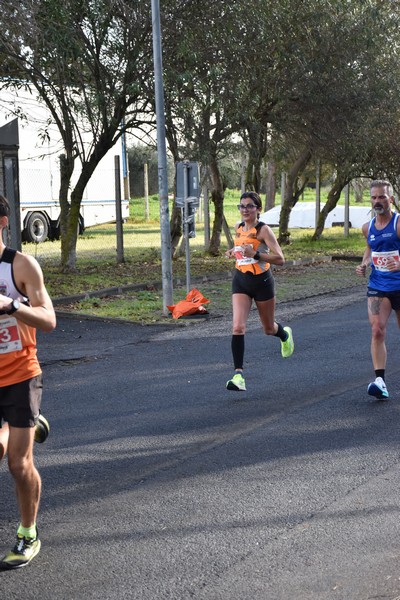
225, 192, 294, 390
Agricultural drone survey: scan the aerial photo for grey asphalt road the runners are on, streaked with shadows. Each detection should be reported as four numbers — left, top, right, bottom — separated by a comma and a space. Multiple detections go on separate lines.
0, 293, 400, 600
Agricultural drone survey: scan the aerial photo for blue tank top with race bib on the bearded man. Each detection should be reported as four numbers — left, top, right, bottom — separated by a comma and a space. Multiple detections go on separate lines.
367, 213, 400, 292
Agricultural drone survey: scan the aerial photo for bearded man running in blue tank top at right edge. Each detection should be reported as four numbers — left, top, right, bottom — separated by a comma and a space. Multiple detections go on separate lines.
356, 180, 400, 400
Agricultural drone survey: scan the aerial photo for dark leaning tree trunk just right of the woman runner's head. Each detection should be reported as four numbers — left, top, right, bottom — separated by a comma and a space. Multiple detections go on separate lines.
278, 148, 311, 245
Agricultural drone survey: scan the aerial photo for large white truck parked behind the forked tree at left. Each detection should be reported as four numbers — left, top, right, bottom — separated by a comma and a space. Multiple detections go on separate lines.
0, 92, 129, 243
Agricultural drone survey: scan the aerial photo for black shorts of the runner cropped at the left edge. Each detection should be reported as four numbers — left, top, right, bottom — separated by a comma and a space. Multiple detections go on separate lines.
0, 375, 43, 427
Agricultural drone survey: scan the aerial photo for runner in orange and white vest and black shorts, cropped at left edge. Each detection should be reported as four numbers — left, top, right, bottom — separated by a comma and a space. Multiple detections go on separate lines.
0, 196, 56, 569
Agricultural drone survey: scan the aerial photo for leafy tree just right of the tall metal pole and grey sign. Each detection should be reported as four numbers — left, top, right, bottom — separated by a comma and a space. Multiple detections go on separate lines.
158, 0, 268, 254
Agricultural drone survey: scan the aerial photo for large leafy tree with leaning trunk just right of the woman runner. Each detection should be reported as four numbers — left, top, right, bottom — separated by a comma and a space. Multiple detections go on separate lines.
253, 0, 398, 243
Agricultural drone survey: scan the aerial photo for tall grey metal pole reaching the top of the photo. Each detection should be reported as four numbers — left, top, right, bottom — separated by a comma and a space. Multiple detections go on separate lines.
151, 0, 173, 315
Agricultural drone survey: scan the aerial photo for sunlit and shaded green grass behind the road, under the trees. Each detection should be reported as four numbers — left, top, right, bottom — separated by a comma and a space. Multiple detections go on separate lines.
23, 190, 365, 323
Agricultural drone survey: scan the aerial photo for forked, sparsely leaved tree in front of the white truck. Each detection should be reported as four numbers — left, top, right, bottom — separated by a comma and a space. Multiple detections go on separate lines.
0, 0, 152, 270
